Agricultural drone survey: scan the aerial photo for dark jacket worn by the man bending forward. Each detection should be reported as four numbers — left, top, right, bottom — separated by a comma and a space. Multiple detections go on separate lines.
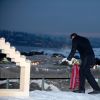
67, 35, 95, 60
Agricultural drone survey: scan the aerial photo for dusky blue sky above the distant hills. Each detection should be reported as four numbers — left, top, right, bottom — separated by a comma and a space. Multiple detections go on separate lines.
0, 0, 100, 36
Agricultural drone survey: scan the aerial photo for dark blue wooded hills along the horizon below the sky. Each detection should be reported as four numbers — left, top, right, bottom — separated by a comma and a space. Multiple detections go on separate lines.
0, 30, 100, 48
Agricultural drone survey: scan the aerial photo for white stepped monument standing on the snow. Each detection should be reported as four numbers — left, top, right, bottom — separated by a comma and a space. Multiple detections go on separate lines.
0, 38, 31, 96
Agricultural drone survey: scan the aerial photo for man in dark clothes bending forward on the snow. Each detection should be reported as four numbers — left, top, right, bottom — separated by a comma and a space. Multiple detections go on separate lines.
67, 33, 100, 94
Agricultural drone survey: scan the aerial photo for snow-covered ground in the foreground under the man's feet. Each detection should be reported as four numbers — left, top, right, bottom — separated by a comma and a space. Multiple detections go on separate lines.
0, 90, 100, 100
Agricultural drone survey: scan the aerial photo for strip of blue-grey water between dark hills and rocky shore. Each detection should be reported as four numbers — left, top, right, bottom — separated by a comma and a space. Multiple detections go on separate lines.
15, 46, 100, 58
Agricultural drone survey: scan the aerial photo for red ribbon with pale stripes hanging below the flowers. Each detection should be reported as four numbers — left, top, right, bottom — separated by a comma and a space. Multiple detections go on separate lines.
70, 64, 79, 91
